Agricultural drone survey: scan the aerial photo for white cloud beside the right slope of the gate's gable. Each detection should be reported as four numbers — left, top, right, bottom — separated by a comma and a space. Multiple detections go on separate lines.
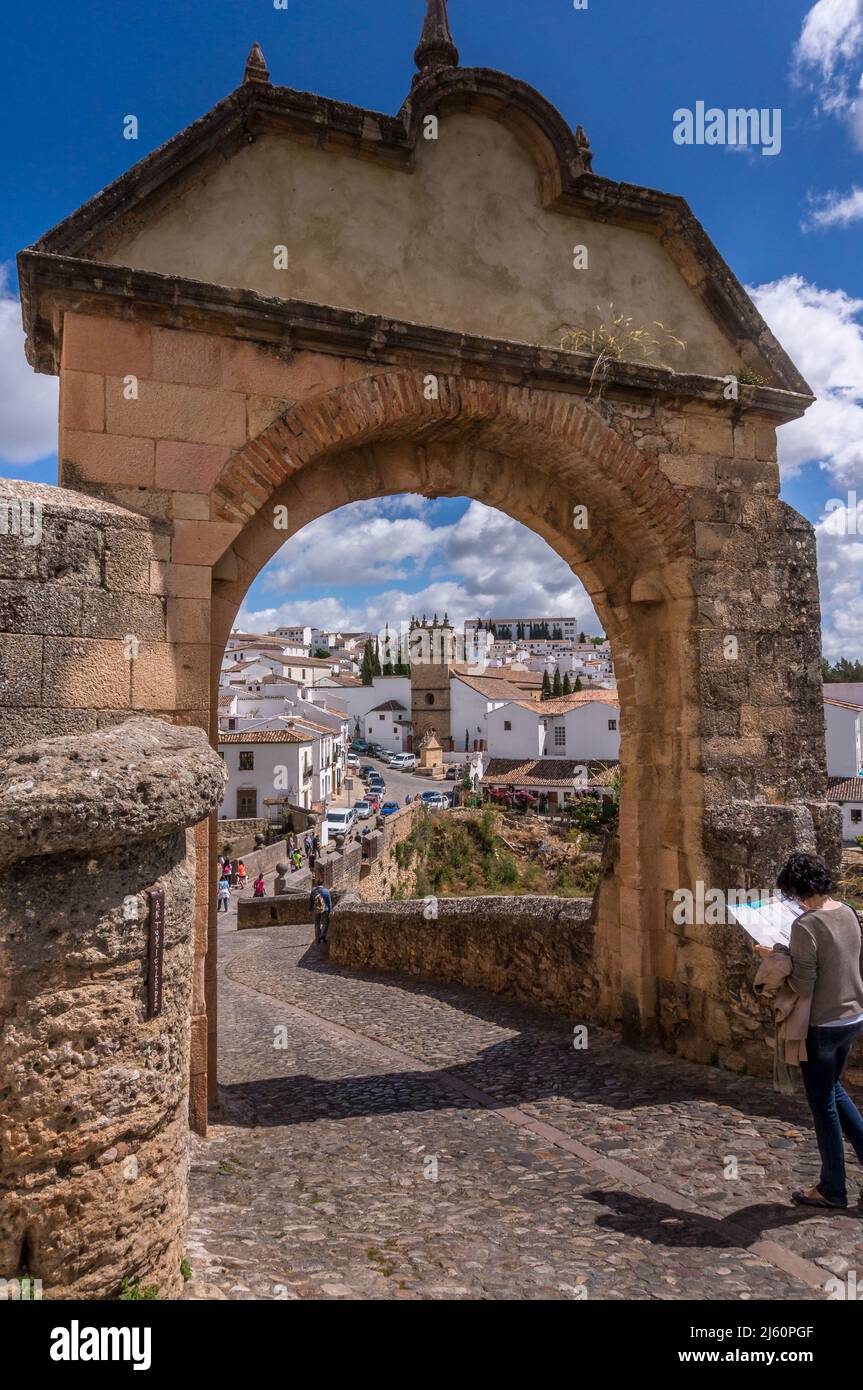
750, 275, 863, 488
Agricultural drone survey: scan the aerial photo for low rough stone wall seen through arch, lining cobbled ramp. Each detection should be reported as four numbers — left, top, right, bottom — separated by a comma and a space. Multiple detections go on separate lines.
329, 897, 602, 1023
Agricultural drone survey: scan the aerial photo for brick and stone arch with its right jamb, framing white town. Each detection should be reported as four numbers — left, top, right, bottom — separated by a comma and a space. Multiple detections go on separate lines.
204, 370, 703, 1095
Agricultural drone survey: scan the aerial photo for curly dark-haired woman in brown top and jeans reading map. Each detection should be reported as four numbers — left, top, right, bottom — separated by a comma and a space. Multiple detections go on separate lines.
762, 853, 863, 1211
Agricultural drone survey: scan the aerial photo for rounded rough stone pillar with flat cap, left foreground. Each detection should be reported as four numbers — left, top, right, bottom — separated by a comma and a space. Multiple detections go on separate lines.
0, 720, 224, 1298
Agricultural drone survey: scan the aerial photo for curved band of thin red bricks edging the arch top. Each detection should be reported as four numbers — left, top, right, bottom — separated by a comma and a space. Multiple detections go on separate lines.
214, 368, 691, 559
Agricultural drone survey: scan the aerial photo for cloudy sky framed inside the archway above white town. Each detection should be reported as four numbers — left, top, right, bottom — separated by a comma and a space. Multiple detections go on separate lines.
238, 498, 599, 632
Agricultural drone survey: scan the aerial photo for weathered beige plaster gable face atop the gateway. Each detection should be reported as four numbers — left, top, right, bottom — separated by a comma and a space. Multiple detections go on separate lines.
89, 113, 741, 377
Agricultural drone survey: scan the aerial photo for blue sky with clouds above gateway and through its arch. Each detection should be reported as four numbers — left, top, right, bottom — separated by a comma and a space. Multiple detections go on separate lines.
0, 0, 863, 656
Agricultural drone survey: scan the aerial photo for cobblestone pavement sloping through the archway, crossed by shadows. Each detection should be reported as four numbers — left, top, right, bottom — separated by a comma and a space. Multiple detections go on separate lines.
188, 915, 863, 1300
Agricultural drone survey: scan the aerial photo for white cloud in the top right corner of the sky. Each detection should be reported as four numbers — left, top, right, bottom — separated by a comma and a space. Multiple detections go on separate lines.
794, 0, 863, 143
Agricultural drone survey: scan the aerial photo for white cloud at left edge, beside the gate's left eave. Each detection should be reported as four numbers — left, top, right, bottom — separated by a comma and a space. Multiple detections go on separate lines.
0, 265, 57, 464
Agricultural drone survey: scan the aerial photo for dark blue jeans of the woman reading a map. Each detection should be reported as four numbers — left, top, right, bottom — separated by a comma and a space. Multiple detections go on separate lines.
800, 1023, 863, 1207
